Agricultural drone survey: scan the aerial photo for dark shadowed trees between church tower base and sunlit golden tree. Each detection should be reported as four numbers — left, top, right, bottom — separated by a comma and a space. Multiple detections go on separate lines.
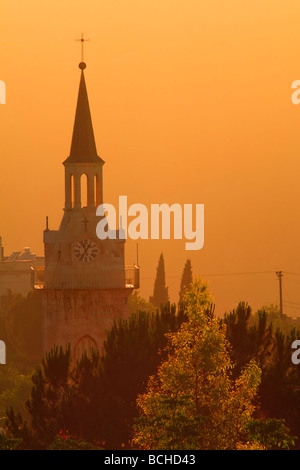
8, 304, 184, 449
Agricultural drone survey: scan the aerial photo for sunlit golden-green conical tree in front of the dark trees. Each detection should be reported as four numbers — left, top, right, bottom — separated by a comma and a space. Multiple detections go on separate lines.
133, 280, 261, 450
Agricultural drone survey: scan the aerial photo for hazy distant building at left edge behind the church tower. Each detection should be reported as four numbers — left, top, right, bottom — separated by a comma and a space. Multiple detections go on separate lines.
0, 237, 45, 309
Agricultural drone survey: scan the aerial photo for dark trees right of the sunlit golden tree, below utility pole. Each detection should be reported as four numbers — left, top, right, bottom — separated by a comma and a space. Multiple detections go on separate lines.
221, 302, 300, 445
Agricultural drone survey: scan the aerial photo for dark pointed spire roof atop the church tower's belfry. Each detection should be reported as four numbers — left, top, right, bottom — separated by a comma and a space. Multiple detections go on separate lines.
64, 62, 103, 163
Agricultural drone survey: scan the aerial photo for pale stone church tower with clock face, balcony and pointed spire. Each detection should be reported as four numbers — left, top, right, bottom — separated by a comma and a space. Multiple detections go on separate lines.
43, 62, 139, 358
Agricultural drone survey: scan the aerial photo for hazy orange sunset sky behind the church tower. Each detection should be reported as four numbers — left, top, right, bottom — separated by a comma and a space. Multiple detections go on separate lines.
0, 0, 300, 316
